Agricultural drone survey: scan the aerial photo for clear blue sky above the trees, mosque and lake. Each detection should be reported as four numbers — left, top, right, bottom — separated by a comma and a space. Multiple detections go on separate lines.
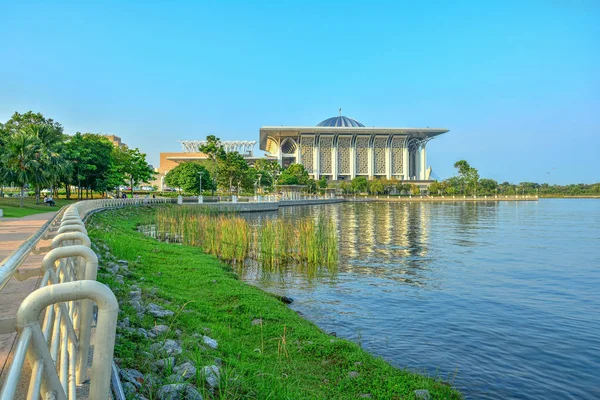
0, 0, 600, 184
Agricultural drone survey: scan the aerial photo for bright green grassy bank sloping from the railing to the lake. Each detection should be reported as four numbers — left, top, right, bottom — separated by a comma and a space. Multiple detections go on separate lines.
88, 207, 461, 399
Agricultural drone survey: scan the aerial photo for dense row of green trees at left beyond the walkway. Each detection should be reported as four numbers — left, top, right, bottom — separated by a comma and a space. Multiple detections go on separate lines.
0, 111, 154, 207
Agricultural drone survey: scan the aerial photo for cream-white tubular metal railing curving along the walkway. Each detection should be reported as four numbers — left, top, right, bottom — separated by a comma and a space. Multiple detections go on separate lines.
0, 198, 172, 400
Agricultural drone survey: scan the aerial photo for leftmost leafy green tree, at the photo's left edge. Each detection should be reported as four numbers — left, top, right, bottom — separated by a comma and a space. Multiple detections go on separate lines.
0, 130, 41, 207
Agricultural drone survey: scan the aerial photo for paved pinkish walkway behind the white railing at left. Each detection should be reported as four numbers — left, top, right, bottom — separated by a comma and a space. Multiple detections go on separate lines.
0, 212, 56, 384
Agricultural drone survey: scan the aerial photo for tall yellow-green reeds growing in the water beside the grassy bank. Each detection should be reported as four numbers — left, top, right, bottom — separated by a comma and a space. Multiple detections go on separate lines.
156, 207, 338, 269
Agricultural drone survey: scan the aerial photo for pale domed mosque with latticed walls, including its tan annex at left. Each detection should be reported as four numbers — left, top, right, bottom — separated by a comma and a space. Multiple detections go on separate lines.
154, 110, 448, 187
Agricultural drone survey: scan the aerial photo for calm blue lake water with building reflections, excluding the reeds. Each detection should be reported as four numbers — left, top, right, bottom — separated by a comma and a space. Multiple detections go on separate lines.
237, 199, 600, 399
